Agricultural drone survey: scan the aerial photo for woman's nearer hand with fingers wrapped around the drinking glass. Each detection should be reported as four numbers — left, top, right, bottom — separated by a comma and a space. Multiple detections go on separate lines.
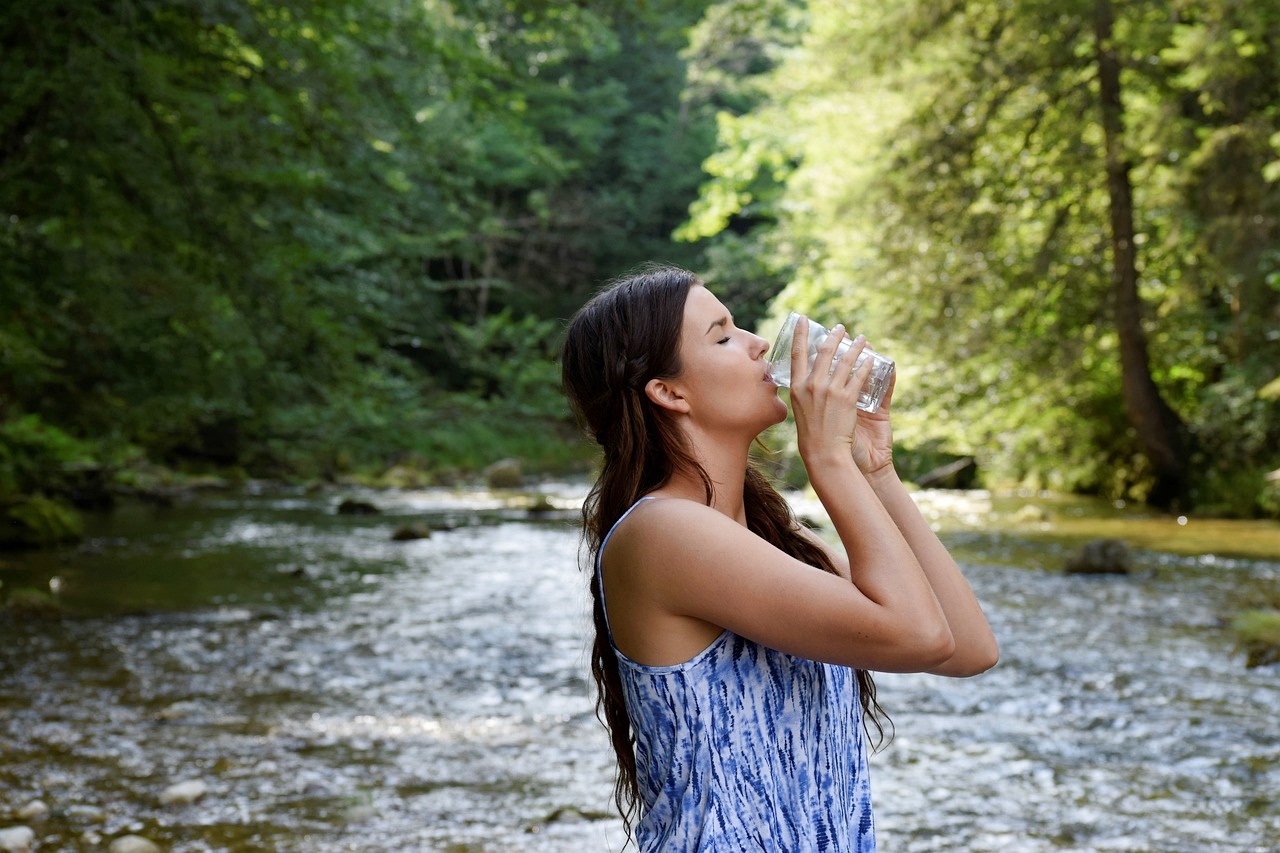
791, 316, 872, 466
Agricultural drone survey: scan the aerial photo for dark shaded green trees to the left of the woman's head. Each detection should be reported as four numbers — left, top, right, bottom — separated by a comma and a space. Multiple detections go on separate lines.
0, 0, 714, 491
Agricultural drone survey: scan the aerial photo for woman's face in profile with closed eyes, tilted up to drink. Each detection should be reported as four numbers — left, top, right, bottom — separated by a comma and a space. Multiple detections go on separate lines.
673, 286, 787, 438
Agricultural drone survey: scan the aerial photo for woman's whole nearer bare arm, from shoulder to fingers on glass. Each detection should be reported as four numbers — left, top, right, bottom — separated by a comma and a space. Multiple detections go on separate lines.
603, 320, 955, 671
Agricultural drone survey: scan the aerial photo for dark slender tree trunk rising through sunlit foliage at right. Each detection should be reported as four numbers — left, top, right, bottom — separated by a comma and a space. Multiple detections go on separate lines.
1094, 0, 1188, 507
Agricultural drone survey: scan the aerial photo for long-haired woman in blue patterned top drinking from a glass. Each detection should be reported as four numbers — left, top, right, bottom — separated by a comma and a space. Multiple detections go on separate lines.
562, 266, 997, 853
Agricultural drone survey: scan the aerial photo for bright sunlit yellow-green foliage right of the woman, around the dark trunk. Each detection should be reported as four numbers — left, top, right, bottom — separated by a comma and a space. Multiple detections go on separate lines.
682, 0, 1280, 514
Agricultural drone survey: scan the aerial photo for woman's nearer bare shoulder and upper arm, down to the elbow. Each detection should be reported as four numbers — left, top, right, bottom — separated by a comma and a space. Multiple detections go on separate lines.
602, 498, 950, 671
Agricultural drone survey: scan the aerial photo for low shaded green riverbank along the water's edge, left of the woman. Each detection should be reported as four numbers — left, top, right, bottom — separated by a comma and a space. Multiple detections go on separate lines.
0, 416, 593, 552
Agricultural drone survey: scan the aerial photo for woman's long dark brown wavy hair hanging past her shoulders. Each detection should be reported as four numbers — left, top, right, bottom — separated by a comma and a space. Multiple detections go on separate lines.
561, 265, 887, 838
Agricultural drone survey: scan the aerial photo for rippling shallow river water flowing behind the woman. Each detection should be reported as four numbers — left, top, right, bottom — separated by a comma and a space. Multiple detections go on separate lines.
0, 484, 1280, 853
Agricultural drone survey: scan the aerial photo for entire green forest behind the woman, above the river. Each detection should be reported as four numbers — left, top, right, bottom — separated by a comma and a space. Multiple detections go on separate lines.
0, 0, 1280, 538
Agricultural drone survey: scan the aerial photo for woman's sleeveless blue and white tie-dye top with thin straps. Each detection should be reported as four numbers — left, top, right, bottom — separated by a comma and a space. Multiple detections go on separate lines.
595, 498, 876, 853
